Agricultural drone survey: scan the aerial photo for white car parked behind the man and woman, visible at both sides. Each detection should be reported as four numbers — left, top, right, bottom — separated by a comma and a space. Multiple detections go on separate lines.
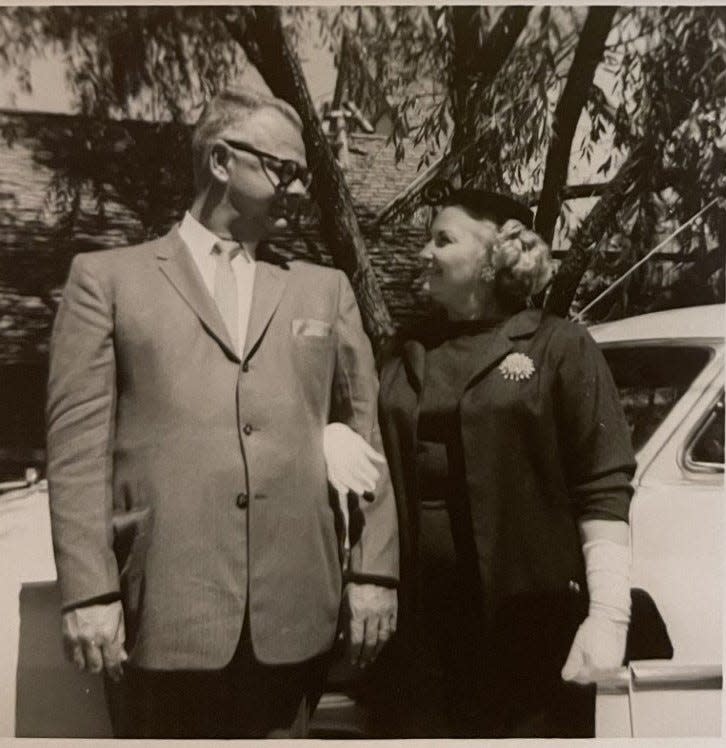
0, 306, 724, 737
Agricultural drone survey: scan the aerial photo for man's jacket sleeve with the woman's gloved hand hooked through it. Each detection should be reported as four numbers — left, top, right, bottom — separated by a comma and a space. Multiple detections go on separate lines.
331, 272, 399, 586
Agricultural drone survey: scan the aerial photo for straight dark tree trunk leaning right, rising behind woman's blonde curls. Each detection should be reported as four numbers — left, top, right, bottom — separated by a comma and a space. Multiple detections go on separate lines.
535, 6, 617, 244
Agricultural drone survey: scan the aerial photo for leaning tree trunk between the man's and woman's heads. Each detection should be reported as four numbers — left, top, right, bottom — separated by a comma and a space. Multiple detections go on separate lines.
227, 6, 394, 350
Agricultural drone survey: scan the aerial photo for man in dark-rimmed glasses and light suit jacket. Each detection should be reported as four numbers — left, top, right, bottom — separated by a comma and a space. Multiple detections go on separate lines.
48, 87, 398, 737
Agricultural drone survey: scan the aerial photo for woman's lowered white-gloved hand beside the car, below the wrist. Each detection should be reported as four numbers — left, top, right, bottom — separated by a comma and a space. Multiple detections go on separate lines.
562, 616, 628, 685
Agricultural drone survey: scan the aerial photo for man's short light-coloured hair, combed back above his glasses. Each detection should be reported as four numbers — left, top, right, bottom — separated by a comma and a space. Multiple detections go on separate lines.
192, 88, 302, 190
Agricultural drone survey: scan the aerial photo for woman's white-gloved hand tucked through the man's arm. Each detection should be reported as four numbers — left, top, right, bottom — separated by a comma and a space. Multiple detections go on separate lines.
323, 423, 386, 500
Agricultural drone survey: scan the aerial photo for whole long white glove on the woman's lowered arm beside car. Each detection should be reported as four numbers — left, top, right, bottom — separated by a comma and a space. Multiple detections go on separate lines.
562, 540, 630, 684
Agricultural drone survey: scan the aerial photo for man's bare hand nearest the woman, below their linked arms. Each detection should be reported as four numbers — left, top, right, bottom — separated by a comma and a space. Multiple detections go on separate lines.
345, 583, 398, 668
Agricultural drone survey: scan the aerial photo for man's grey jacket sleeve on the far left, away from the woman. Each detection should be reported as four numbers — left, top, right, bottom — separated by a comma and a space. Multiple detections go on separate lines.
46, 256, 119, 609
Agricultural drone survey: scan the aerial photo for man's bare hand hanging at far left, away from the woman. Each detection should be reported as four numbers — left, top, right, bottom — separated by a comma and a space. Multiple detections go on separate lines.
62, 602, 128, 681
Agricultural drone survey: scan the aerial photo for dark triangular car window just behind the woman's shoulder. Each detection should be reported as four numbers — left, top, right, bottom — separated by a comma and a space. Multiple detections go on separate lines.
603, 344, 713, 452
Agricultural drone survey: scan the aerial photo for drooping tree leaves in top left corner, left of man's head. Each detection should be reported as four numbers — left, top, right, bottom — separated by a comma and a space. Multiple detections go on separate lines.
0, 6, 245, 120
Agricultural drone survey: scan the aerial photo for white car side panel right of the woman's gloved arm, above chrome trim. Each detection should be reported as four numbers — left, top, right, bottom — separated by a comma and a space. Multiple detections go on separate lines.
631, 357, 723, 665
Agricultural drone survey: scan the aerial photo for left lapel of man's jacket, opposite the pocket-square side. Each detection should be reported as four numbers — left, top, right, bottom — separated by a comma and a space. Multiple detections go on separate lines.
156, 227, 240, 361
